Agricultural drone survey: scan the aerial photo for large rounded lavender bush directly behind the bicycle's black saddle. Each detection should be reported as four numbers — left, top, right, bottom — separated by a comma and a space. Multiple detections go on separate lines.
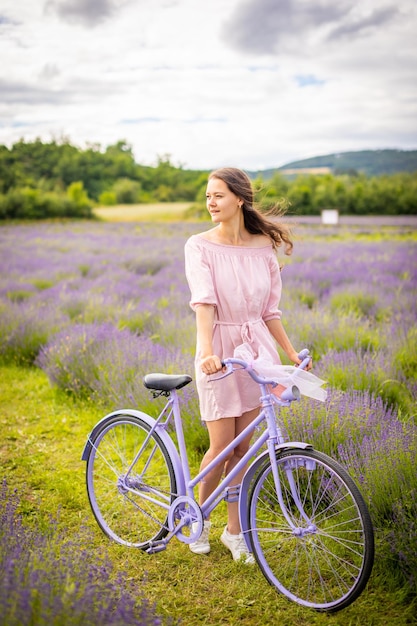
36, 323, 193, 408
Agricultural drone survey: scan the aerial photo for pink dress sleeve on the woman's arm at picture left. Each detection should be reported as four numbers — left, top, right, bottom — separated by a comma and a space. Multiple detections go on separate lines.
184, 236, 217, 311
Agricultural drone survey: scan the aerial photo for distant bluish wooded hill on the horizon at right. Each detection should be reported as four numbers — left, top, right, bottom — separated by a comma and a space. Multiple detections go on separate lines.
251, 150, 417, 179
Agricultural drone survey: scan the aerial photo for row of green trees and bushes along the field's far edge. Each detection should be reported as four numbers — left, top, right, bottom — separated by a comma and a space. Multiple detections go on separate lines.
0, 139, 417, 220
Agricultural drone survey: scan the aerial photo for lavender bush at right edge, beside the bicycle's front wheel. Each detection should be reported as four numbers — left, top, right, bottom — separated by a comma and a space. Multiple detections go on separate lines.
338, 415, 417, 595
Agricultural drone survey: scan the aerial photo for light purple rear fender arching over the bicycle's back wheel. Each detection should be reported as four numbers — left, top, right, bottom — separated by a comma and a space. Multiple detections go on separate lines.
81, 409, 186, 496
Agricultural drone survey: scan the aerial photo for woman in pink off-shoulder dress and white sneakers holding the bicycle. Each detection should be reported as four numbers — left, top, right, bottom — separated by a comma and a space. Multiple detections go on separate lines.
185, 168, 311, 563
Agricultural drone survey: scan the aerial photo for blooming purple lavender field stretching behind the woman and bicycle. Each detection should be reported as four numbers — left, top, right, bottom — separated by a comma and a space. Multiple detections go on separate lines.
0, 222, 417, 595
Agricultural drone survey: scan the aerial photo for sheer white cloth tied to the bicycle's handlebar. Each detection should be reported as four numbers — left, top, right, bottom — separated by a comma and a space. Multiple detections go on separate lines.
233, 343, 327, 402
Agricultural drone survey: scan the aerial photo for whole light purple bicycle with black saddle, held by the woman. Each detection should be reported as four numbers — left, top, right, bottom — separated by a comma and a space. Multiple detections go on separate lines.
82, 351, 374, 612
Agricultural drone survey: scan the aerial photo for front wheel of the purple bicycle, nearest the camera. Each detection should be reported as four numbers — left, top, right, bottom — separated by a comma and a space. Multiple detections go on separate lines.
248, 450, 374, 612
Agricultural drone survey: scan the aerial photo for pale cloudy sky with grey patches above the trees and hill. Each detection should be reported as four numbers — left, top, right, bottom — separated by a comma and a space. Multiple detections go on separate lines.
0, 0, 417, 170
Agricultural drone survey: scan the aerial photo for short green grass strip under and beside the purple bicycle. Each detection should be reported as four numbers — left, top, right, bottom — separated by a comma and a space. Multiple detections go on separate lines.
0, 366, 416, 626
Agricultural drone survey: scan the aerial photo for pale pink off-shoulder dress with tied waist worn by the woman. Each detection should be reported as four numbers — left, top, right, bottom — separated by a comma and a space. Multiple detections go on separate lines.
185, 235, 282, 421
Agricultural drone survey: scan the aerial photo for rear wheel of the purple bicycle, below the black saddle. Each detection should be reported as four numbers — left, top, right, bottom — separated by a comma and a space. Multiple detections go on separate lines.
86, 415, 177, 550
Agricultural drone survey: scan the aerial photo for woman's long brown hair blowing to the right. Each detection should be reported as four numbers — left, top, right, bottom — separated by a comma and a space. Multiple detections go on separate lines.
209, 167, 293, 254
